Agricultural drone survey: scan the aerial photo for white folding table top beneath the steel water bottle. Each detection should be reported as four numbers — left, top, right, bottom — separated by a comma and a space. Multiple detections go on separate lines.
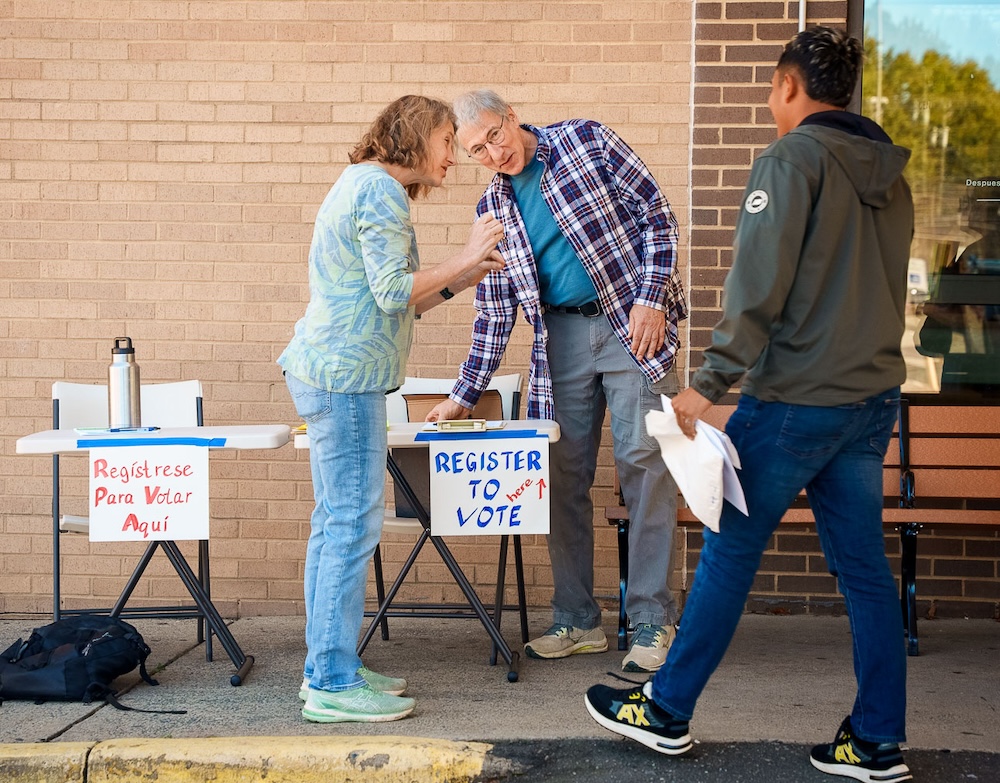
16, 424, 291, 454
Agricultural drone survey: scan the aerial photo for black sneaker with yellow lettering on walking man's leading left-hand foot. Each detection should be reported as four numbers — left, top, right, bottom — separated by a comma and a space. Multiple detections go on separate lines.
583, 682, 692, 756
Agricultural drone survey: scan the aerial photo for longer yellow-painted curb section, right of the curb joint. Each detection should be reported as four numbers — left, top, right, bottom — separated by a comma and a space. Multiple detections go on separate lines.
87, 737, 492, 783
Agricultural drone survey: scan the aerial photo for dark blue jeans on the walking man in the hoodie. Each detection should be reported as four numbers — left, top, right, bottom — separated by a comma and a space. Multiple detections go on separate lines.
653, 389, 906, 742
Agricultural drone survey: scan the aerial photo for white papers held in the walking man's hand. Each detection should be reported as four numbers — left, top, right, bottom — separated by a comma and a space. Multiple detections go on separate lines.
646, 397, 747, 533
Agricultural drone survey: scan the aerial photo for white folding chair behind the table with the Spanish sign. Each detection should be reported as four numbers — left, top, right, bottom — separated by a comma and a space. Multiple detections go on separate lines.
52, 381, 212, 660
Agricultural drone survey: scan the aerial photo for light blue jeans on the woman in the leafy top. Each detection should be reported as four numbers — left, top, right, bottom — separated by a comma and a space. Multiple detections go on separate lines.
285, 373, 388, 691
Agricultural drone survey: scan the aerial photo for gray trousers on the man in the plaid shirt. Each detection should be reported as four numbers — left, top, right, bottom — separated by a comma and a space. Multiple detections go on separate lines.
545, 311, 678, 628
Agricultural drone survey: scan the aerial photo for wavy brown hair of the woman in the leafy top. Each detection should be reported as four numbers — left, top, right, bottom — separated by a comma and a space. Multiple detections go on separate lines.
348, 95, 455, 198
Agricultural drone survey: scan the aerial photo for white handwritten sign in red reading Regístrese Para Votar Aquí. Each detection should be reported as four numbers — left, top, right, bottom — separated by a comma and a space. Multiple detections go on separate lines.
90, 445, 208, 541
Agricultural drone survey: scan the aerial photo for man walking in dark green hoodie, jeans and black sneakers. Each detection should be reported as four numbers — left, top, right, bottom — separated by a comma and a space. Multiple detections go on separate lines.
586, 27, 913, 783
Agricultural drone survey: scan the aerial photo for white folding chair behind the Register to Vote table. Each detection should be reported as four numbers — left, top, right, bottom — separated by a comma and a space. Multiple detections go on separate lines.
358, 373, 528, 663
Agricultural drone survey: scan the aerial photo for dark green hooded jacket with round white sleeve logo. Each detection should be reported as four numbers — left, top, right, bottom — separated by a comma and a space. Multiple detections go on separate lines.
691, 111, 913, 406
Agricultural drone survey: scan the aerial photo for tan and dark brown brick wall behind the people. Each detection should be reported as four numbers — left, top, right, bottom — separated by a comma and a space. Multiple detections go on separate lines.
0, 0, 998, 616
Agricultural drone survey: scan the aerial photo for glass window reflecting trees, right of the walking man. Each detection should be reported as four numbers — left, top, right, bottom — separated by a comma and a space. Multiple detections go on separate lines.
861, 0, 1000, 403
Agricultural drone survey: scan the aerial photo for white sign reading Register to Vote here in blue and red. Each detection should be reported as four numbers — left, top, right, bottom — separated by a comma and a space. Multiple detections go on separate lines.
429, 434, 549, 536
